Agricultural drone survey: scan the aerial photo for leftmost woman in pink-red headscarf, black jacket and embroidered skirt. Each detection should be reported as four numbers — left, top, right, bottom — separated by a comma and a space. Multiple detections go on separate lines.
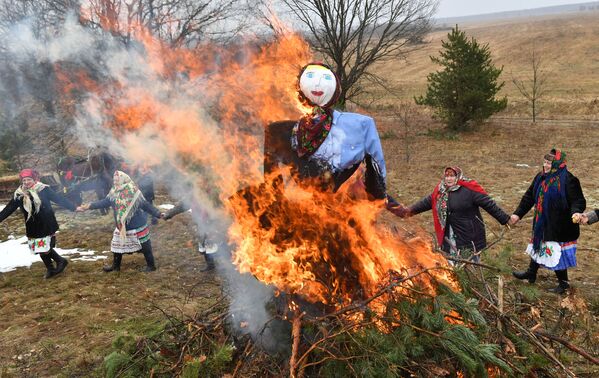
0, 169, 75, 278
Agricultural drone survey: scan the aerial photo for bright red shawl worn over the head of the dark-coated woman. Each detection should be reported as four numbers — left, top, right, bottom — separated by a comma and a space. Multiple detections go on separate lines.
431, 167, 487, 247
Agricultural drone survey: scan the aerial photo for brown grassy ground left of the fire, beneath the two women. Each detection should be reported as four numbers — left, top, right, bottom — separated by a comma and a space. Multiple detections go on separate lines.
0, 196, 225, 377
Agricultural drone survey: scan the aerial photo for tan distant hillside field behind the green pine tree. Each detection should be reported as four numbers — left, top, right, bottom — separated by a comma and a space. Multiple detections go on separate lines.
374, 14, 599, 120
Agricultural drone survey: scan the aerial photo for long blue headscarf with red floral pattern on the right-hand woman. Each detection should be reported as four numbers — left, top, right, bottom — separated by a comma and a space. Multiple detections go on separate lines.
532, 149, 568, 252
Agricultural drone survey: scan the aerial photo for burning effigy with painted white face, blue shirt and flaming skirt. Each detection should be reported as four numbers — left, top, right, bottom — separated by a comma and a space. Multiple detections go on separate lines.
229, 63, 458, 318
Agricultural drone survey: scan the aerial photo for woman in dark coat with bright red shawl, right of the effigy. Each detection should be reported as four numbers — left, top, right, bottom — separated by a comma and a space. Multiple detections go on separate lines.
395, 167, 510, 261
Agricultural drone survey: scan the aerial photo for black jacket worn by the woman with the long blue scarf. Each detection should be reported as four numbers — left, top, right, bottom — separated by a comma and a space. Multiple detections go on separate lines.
514, 172, 586, 242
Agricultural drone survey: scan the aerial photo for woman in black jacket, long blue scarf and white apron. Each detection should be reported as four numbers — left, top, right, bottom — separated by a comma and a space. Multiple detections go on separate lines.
510, 149, 586, 294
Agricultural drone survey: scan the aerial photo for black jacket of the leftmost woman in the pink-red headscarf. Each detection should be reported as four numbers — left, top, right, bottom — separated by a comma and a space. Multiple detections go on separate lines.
0, 187, 76, 238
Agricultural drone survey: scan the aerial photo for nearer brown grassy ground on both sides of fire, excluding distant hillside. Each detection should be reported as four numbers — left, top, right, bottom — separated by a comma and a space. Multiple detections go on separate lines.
0, 114, 599, 377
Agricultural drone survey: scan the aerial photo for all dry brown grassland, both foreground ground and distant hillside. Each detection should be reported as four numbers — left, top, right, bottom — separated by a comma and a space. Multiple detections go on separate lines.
0, 13, 599, 377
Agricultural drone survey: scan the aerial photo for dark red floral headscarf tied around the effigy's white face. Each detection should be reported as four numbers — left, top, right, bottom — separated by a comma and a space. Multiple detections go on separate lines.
293, 62, 341, 157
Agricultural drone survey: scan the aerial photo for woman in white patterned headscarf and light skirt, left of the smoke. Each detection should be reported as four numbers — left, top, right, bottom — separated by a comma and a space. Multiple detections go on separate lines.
77, 171, 162, 272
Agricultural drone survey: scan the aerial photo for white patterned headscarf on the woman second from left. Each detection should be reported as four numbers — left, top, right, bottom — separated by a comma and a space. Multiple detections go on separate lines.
108, 171, 144, 238
